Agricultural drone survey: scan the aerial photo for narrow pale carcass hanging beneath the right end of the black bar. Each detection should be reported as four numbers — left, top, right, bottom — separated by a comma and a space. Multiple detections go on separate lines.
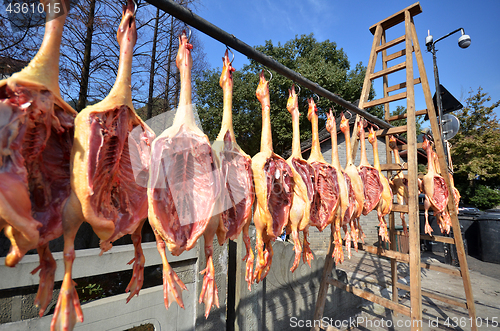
368, 127, 393, 242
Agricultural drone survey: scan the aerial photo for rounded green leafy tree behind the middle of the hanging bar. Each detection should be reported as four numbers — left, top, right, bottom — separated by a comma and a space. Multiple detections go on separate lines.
195, 34, 381, 155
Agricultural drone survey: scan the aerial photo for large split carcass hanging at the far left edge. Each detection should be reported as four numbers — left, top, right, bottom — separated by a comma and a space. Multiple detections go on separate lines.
0, 0, 76, 316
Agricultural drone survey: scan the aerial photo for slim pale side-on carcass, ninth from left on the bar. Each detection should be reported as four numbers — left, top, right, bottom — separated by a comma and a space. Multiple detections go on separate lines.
340, 113, 365, 252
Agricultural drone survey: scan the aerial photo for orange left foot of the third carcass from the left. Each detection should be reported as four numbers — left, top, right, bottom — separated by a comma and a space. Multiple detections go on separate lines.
155, 231, 187, 309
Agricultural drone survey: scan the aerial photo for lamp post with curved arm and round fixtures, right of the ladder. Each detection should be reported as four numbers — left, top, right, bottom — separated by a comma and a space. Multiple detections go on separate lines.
425, 28, 470, 169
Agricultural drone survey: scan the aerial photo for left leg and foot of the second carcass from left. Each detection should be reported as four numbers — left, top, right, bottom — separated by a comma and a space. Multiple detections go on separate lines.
50, 192, 84, 331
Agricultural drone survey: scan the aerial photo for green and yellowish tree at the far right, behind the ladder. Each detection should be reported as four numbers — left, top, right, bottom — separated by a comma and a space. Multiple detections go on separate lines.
450, 87, 500, 209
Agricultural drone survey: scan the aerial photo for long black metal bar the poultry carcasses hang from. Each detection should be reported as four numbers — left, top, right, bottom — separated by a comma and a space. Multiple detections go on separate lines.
146, 0, 393, 129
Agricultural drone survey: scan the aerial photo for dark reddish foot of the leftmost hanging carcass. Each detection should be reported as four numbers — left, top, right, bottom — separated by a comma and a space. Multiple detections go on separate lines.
31, 244, 57, 317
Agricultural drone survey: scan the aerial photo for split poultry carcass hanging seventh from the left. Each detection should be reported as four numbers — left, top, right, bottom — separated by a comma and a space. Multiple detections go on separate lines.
307, 98, 340, 231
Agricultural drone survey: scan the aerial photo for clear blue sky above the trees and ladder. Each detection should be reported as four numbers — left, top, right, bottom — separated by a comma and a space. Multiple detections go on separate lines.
195, 0, 500, 124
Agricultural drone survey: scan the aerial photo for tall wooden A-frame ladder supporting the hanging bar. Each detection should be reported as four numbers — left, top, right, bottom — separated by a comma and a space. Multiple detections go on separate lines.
311, 2, 477, 331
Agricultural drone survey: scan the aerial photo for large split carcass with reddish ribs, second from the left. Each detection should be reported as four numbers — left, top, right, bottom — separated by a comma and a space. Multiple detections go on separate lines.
51, 0, 154, 330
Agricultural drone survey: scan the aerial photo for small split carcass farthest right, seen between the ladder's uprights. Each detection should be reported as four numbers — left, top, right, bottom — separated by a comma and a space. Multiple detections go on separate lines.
421, 136, 449, 235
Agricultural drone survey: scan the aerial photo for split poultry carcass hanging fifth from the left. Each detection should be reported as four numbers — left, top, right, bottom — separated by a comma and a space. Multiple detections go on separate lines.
252, 71, 294, 283
